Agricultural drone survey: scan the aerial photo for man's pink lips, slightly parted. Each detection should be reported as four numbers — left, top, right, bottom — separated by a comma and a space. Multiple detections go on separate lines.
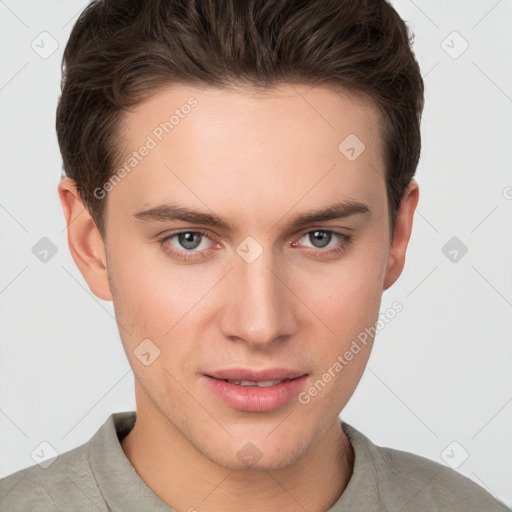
202, 368, 308, 413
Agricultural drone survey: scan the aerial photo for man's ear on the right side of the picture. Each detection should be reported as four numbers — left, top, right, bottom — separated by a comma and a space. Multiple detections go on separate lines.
384, 180, 419, 290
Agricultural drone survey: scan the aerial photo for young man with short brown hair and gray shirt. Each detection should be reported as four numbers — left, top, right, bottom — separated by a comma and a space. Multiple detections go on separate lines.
0, 0, 506, 512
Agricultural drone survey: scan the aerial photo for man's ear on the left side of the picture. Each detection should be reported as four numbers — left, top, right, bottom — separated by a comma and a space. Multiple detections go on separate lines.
58, 177, 112, 300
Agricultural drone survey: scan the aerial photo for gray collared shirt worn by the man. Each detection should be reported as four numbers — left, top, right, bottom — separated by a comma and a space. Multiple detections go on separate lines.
0, 412, 508, 512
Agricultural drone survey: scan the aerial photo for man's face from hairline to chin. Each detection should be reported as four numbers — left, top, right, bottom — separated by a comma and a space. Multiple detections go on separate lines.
62, 85, 418, 469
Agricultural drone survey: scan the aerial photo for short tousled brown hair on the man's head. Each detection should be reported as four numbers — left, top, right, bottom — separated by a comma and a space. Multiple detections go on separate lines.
56, 0, 424, 236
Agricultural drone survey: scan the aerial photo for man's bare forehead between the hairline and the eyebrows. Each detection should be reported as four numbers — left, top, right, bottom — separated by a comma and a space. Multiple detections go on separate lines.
109, 84, 384, 225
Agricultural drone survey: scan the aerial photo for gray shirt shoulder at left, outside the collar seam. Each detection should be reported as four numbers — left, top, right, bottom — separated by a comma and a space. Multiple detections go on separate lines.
0, 436, 106, 512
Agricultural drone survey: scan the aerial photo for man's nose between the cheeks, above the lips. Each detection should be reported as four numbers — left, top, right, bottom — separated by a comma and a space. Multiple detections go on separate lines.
220, 246, 297, 350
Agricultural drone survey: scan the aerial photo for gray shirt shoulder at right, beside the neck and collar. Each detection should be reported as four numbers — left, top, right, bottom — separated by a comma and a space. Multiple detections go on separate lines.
343, 423, 509, 512
